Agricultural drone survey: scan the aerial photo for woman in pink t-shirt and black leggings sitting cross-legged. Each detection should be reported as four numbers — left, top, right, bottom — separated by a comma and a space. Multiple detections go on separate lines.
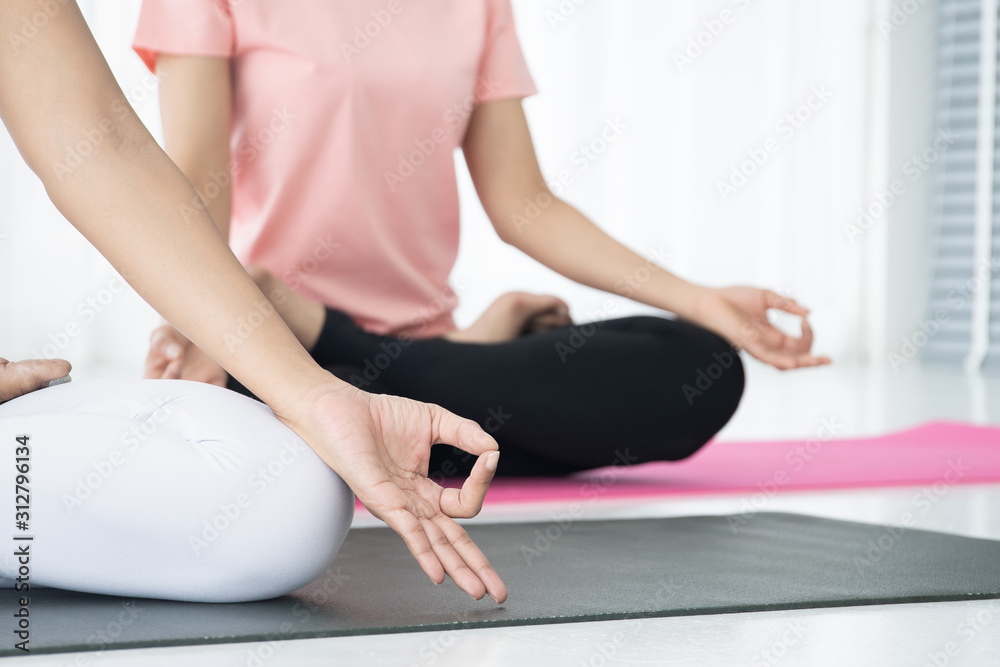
135, 0, 829, 475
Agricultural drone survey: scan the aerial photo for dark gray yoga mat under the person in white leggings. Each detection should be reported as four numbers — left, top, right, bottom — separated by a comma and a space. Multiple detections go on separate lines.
0, 513, 1000, 655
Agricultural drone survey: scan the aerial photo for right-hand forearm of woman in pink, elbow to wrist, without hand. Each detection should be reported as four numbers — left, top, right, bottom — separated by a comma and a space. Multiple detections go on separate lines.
504, 198, 705, 318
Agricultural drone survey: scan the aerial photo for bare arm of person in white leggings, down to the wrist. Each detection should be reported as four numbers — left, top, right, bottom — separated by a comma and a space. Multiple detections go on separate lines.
0, 0, 332, 412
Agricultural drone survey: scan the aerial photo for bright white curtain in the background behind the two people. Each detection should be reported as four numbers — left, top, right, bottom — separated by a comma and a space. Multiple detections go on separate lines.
0, 0, 888, 377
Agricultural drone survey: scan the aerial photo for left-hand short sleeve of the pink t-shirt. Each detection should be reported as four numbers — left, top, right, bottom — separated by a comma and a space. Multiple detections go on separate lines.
132, 0, 235, 72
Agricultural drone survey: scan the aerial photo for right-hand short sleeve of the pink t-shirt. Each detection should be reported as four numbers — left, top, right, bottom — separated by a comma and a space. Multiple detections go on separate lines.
478, 0, 538, 104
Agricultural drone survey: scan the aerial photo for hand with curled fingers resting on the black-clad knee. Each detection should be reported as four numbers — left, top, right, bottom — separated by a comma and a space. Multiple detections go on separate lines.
692, 287, 831, 370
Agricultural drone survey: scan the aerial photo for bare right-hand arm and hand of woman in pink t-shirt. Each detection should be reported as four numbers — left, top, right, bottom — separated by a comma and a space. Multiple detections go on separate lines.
462, 100, 827, 368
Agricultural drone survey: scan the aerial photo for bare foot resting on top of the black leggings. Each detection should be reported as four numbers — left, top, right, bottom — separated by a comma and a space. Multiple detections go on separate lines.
444, 292, 573, 343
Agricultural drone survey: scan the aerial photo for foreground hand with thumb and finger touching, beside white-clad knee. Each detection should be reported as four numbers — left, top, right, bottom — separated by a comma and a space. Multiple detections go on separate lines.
278, 382, 507, 603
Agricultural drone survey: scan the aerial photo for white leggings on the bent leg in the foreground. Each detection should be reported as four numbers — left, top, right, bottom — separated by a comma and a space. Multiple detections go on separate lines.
0, 380, 354, 602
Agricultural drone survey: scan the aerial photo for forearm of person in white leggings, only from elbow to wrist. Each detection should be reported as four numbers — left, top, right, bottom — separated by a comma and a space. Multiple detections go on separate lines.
49, 139, 330, 411
